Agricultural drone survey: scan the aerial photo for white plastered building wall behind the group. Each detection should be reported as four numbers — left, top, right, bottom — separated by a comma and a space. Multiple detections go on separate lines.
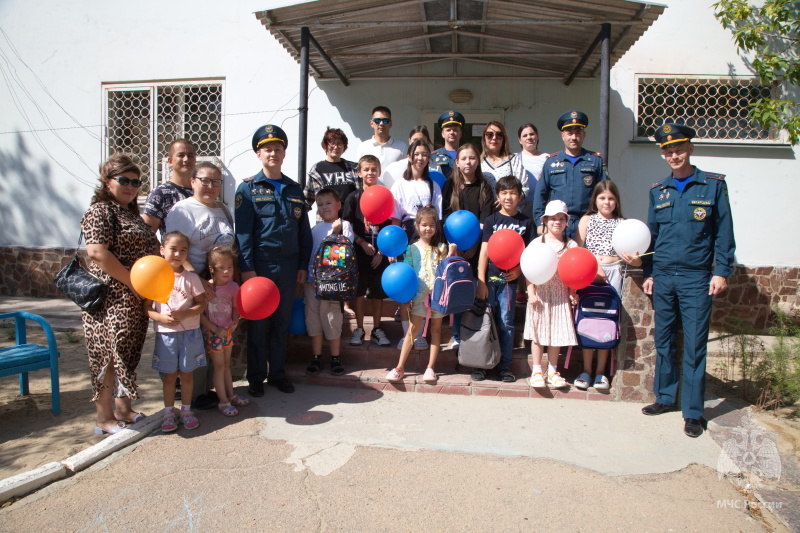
0, 0, 800, 265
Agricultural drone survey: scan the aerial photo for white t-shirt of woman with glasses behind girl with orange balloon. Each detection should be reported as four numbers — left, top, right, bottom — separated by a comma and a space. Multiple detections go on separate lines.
167, 197, 235, 272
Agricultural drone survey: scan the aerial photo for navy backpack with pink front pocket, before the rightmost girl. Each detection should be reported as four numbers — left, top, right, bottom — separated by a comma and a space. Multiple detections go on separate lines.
575, 283, 622, 350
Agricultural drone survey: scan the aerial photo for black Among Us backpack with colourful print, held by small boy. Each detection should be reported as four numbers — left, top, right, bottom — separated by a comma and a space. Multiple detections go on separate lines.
313, 234, 358, 302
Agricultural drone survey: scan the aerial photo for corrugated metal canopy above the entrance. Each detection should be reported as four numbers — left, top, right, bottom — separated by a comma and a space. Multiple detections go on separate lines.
256, 0, 664, 84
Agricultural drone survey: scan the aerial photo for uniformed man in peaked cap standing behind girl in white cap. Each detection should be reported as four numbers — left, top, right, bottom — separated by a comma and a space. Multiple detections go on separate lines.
533, 111, 608, 239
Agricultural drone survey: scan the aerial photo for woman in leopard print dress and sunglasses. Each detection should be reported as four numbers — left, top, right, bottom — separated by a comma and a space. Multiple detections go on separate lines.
81, 154, 158, 433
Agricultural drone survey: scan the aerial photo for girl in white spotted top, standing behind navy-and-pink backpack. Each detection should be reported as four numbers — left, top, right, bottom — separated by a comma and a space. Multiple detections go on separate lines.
575, 180, 646, 390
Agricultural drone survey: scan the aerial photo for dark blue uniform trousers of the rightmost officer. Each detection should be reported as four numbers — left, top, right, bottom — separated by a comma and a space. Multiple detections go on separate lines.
653, 271, 712, 419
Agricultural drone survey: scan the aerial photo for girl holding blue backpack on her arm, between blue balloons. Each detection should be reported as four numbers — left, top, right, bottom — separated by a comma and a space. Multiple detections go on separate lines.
386, 207, 456, 383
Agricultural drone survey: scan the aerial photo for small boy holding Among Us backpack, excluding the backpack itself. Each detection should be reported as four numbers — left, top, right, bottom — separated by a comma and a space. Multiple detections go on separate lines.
304, 187, 355, 376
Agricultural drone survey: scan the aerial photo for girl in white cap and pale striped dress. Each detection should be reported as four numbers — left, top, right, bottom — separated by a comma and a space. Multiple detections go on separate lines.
524, 200, 578, 389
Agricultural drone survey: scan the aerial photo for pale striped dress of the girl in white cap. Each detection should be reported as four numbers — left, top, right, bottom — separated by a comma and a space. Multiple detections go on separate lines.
524, 239, 578, 346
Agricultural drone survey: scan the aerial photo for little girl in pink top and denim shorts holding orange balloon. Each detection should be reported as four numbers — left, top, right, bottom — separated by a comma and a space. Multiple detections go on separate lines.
143, 231, 206, 433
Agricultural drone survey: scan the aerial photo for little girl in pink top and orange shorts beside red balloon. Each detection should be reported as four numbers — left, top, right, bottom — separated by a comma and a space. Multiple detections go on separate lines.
200, 246, 250, 416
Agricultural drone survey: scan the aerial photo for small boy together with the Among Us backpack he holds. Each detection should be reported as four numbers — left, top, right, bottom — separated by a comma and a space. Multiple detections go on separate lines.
304, 187, 358, 376
